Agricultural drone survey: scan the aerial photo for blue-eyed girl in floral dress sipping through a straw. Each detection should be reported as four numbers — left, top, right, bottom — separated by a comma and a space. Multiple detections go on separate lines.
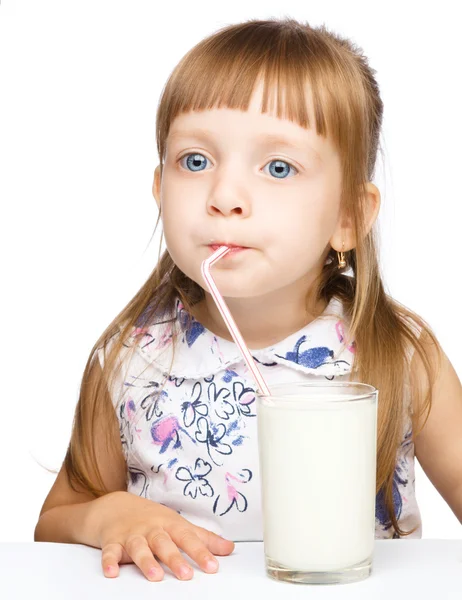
35, 18, 462, 580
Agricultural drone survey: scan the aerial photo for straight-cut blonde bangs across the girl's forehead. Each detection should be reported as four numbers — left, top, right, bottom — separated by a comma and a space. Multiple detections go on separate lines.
157, 19, 349, 164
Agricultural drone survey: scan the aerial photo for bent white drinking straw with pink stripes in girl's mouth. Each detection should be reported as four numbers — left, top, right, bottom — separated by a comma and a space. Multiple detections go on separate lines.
201, 246, 270, 396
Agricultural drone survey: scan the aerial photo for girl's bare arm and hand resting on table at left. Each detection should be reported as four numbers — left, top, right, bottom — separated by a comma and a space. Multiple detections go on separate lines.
34, 362, 234, 581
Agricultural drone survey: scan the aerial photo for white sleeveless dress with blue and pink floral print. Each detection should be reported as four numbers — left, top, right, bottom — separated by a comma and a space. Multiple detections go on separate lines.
98, 298, 422, 541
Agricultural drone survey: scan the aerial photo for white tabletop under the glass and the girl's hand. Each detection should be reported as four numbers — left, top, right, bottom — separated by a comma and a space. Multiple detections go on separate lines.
0, 539, 462, 600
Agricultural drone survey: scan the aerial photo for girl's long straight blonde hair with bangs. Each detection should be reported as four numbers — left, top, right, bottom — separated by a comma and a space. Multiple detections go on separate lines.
64, 18, 439, 536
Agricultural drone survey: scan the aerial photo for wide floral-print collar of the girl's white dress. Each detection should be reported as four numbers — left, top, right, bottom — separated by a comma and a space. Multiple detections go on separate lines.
131, 298, 355, 379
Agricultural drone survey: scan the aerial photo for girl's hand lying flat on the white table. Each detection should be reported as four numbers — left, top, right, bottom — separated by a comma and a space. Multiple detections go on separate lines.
89, 492, 234, 581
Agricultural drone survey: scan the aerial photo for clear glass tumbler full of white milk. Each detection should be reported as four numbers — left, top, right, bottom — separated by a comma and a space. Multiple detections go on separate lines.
257, 381, 378, 584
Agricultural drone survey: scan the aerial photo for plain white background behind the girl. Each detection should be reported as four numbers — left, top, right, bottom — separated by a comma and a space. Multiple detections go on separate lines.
0, 0, 462, 541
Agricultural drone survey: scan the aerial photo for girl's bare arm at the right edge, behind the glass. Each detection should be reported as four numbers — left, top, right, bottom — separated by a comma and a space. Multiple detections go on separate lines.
411, 330, 462, 523
